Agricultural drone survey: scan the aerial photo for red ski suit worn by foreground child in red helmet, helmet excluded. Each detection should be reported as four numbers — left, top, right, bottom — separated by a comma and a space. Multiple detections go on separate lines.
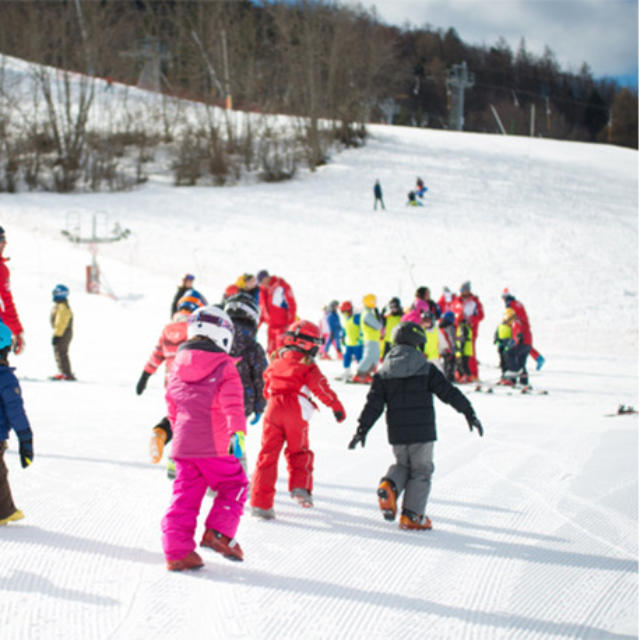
251, 349, 344, 509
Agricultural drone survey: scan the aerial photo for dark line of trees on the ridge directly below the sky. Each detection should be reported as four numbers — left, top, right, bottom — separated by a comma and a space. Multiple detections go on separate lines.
0, 0, 638, 192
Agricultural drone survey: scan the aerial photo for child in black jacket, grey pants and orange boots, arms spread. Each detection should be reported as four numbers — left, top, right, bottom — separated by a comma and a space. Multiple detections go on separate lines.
349, 322, 483, 530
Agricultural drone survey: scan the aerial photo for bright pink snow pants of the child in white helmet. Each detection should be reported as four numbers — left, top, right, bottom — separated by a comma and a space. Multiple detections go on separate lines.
162, 456, 249, 560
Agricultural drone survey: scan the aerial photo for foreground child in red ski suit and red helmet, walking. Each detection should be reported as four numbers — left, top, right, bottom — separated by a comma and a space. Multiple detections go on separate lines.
251, 320, 346, 520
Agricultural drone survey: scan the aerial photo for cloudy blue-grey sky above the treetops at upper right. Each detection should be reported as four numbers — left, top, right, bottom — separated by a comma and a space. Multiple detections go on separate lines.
347, 0, 638, 87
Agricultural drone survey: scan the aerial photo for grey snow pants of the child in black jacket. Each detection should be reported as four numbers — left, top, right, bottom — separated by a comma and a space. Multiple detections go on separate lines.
384, 442, 435, 516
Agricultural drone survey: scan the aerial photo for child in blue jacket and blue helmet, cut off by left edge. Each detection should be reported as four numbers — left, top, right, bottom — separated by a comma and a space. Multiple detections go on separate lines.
0, 323, 33, 525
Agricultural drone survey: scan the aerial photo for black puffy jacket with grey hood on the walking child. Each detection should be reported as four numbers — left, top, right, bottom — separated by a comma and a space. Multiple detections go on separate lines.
358, 344, 473, 444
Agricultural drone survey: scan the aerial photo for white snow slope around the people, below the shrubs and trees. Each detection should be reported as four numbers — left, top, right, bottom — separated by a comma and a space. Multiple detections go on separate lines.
0, 119, 638, 640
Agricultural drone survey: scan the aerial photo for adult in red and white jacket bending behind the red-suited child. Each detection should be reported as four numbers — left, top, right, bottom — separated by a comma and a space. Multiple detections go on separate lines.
258, 270, 296, 353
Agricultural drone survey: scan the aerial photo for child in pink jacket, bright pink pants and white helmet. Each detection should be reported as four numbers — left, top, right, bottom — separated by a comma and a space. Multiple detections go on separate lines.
162, 306, 248, 571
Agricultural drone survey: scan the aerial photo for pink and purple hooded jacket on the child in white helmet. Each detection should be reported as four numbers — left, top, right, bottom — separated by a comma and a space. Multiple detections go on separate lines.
165, 340, 246, 458
